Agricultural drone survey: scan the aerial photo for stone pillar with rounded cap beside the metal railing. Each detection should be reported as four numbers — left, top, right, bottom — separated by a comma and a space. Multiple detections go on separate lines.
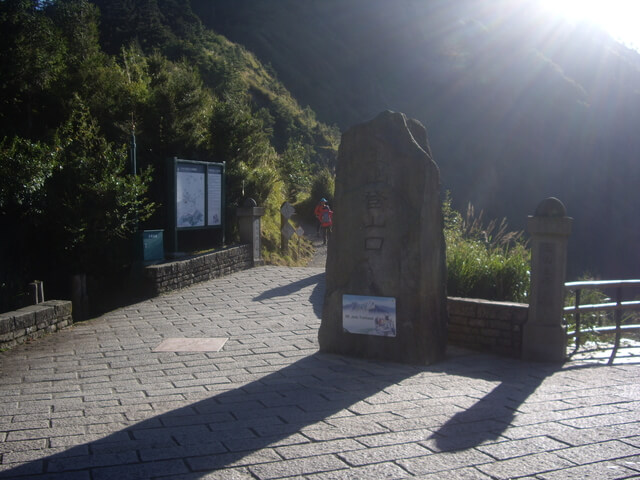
522, 198, 573, 362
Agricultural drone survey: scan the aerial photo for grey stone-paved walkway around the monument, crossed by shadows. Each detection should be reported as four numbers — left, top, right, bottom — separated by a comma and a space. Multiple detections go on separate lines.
0, 267, 640, 480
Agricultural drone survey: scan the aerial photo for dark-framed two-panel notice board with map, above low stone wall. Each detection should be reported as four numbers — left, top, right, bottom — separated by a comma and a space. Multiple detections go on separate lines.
169, 158, 225, 251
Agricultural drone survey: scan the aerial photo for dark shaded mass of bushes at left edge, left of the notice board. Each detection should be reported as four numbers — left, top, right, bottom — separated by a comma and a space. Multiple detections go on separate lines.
0, 99, 155, 311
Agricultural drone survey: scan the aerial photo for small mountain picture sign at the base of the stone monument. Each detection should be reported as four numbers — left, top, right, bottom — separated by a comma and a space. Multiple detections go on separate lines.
342, 295, 396, 337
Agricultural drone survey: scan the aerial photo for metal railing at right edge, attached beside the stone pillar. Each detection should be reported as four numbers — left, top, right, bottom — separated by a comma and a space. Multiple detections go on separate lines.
564, 280, 640, 365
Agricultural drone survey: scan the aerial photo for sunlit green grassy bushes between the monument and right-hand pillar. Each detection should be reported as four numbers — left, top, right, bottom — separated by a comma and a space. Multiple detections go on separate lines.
443, 196, 531, 302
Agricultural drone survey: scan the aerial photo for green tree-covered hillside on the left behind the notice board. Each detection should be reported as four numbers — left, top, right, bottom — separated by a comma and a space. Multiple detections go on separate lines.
0, 0, 339, 311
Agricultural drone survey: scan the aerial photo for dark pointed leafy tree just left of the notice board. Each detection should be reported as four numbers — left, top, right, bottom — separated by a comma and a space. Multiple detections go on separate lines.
46, 100, 154, 272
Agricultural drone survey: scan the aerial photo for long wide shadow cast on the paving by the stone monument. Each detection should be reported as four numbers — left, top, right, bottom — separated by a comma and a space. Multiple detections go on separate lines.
0, 354, 419, 480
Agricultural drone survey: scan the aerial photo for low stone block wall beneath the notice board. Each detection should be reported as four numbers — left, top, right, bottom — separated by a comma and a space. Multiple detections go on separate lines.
144, 245, 253, 296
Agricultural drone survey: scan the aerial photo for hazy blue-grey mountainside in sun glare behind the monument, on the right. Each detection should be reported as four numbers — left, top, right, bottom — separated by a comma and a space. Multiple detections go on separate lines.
198, 0, 640, 279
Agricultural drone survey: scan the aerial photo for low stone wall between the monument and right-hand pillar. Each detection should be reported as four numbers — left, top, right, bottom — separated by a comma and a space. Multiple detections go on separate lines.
448, 297, 529, 358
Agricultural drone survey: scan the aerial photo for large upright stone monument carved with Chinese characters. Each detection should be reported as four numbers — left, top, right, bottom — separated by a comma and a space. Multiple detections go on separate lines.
319, 111, 447, 364
